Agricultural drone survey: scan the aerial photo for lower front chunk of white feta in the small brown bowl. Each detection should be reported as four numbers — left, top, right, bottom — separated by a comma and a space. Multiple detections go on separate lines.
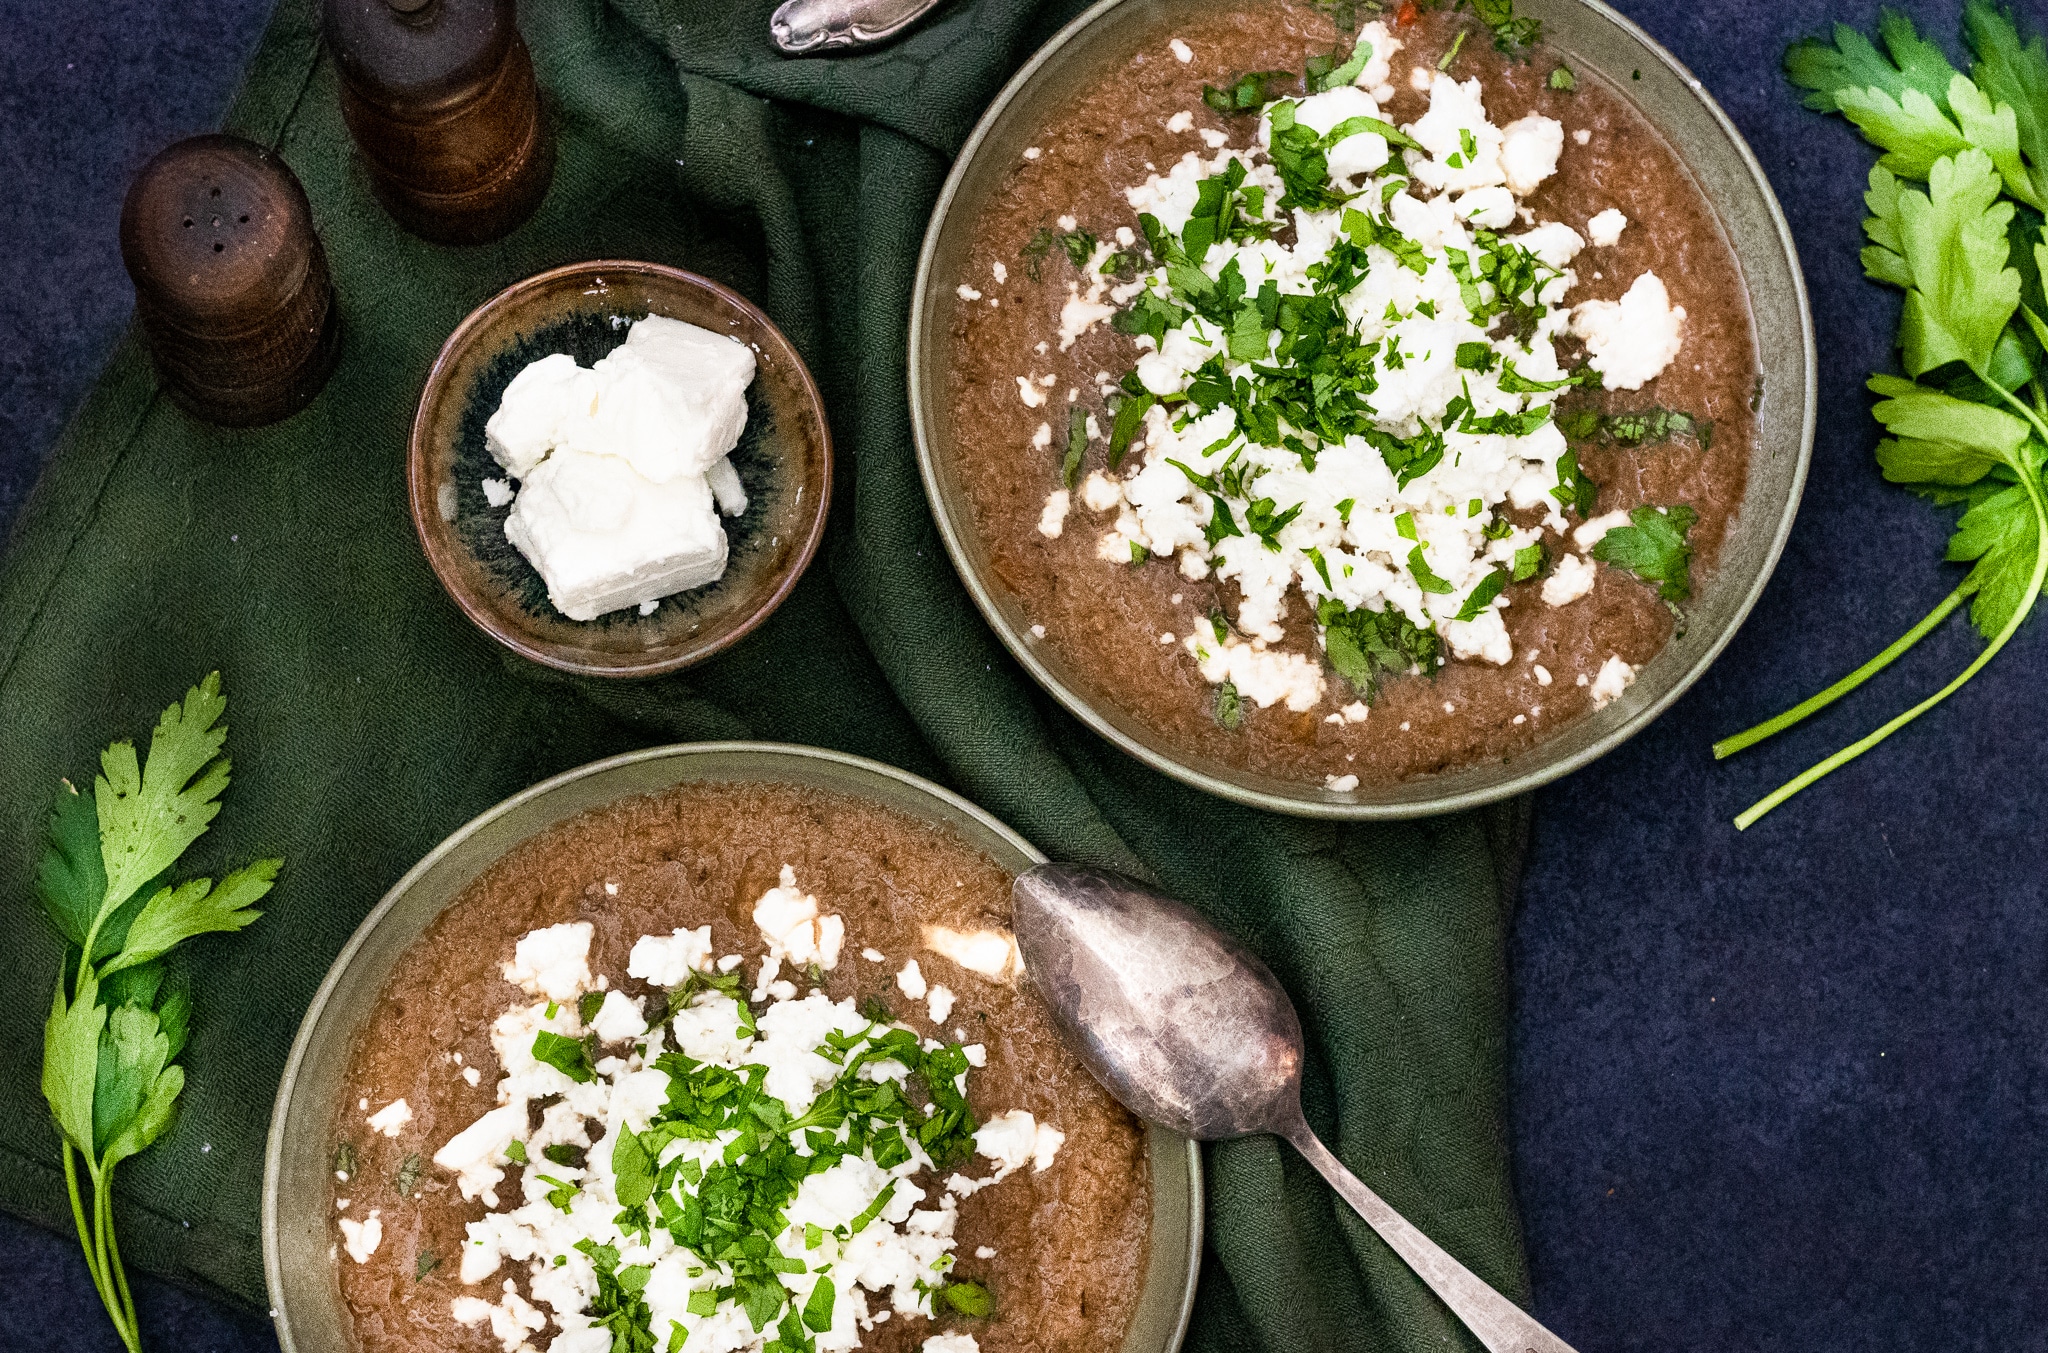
506, 450, 725, 620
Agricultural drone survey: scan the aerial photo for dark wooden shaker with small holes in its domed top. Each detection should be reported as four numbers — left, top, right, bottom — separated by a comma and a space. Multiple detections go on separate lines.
121, 135, 340, 428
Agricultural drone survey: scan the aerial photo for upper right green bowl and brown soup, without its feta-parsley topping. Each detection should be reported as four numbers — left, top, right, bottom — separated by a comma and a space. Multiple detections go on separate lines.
909, 0, 1815, 819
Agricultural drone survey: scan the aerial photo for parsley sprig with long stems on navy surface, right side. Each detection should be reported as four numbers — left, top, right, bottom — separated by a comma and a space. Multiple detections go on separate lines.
1714, 0, 2048, 827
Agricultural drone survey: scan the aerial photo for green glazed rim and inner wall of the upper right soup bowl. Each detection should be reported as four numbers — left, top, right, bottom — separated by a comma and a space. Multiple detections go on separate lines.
909, 0, 1815, 819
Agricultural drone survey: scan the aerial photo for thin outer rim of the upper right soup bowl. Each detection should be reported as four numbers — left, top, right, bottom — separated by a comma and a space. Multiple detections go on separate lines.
905, 0, 1821, 821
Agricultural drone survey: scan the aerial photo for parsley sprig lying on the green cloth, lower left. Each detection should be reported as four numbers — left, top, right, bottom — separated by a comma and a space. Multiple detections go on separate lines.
37, 671, 281, 1353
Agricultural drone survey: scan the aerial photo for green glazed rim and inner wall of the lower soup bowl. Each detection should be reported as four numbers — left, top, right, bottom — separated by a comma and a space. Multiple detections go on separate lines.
262, 743, 1202, 1353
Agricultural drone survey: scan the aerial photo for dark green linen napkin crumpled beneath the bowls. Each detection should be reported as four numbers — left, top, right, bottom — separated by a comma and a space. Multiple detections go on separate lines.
0, 0, 1528, 1351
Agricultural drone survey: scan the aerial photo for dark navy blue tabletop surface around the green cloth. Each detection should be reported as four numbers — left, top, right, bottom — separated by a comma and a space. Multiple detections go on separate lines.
0, 0, 2048, 1353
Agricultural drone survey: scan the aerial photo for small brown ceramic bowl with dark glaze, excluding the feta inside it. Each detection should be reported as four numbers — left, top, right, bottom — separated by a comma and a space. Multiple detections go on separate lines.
406, 260, 831, 678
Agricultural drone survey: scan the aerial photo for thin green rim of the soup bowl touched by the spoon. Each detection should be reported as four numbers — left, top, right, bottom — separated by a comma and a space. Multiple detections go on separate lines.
260, 741, 1208, 1353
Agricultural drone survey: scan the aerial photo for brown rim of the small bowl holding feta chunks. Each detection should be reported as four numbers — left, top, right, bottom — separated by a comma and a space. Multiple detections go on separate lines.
406, 258, 834, 678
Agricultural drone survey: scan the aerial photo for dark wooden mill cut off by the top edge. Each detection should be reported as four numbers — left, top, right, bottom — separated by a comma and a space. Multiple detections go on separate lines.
326, 0, 555, 244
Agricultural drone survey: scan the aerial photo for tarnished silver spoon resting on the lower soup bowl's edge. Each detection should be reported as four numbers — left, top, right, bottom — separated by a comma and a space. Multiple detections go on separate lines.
1012, 864, 1573, 1353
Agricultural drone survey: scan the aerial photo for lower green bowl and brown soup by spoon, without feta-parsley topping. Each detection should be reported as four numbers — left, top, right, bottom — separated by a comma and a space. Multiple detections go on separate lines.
262, 743, 1202, 1353
